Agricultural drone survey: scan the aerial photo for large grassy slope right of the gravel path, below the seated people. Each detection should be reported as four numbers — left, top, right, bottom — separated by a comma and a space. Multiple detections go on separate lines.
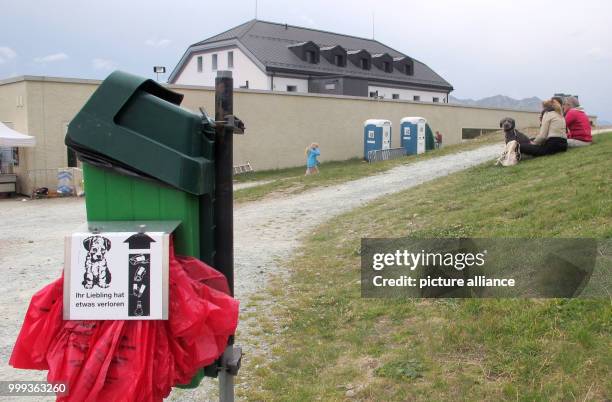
244, 134, 612, 401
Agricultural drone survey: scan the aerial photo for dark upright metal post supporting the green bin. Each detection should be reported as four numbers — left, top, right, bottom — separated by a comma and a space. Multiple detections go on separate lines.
215, 71, 234, 402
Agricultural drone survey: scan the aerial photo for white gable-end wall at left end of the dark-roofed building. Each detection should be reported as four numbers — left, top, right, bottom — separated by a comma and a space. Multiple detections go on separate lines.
176, 46, 270, 89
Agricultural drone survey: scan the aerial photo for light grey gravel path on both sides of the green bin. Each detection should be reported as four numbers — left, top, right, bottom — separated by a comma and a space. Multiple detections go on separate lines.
0, 145, 502, 401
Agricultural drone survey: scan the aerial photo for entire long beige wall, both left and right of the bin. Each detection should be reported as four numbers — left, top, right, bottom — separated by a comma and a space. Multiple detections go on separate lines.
0, 77, 596, 193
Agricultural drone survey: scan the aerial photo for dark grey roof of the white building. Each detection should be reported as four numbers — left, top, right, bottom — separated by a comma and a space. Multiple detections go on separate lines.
173, 20, 453, 90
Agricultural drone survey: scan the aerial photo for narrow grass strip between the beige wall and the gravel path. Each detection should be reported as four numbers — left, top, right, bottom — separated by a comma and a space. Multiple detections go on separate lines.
234, 133, 503, 202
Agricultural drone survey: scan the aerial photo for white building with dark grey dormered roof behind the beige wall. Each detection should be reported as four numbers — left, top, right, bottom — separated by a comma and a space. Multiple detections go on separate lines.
168, 20, 453, 102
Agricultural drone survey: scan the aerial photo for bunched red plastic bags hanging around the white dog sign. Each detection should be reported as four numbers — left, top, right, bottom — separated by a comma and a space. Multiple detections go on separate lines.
9, 242, 238, 401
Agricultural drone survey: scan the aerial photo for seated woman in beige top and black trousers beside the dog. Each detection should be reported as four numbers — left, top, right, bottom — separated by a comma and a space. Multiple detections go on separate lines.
521, 99, 567, 156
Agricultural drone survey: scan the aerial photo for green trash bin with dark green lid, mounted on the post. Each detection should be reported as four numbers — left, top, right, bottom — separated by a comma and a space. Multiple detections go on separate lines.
65, 71, 215, 386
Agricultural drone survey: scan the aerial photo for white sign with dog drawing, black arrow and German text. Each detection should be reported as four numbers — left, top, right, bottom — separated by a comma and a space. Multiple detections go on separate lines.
64, 232, 169, 320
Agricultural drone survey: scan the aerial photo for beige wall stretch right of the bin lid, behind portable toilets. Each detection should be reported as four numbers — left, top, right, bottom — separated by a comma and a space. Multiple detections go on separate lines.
173, 86, 539, 170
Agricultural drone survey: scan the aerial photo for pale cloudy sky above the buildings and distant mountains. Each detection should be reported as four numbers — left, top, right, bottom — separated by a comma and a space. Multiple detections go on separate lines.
0, 0, 612, 120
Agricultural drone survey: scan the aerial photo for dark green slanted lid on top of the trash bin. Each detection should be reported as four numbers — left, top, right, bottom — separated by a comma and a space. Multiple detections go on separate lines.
65, 71, 214, 195
